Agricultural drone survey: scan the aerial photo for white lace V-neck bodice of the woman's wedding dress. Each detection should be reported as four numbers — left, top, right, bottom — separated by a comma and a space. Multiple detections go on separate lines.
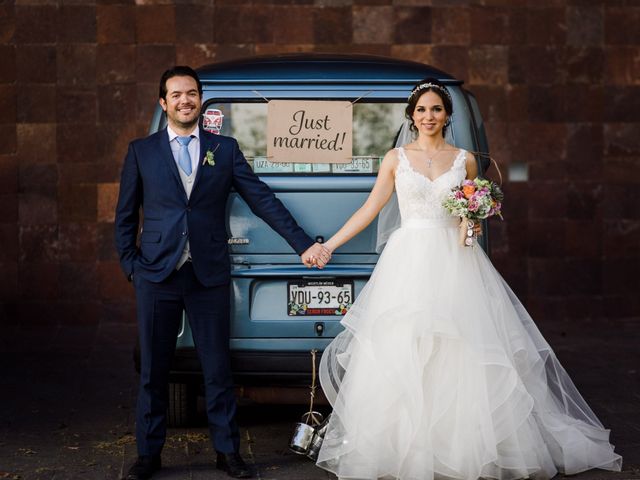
396, 147, 467, 221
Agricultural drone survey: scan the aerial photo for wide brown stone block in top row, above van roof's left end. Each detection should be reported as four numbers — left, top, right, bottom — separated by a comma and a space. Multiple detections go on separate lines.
213, 5, 274, 44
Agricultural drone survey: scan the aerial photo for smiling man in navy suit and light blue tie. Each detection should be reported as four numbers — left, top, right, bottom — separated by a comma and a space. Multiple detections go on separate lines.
115, 66, 330, 480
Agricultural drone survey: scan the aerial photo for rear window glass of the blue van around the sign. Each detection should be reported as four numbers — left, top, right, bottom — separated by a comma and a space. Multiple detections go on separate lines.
201, 101, 405, 175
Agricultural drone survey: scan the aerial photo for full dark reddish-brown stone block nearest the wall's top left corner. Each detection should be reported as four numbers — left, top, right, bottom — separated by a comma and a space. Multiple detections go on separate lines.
14, 5, 58, 43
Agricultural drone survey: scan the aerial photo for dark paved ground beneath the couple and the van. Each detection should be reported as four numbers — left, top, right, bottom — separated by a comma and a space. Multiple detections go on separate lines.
0, 320, 640, 480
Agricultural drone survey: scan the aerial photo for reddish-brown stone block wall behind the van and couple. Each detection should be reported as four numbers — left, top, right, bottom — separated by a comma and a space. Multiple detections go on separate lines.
0, 0, 640, 326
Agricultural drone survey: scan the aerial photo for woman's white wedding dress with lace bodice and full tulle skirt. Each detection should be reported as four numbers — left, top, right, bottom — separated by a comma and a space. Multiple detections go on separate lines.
317, 148, 622, 480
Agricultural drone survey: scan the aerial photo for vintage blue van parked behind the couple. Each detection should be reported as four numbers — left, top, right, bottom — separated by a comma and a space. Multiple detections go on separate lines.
149, 54, 489, 425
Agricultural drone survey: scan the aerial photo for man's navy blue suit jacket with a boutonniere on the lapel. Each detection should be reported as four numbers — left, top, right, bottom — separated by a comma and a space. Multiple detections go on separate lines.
115, 129, 314, 287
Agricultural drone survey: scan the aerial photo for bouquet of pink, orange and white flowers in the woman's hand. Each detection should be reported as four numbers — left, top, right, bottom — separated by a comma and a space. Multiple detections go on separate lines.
442, 178, 504, 247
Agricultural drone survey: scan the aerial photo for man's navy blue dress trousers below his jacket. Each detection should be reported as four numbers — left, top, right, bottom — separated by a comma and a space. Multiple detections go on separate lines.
134, 262, 240, 455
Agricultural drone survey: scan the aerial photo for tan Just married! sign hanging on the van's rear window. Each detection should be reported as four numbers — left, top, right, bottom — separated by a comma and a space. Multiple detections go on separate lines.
267, 100, 353, 163
